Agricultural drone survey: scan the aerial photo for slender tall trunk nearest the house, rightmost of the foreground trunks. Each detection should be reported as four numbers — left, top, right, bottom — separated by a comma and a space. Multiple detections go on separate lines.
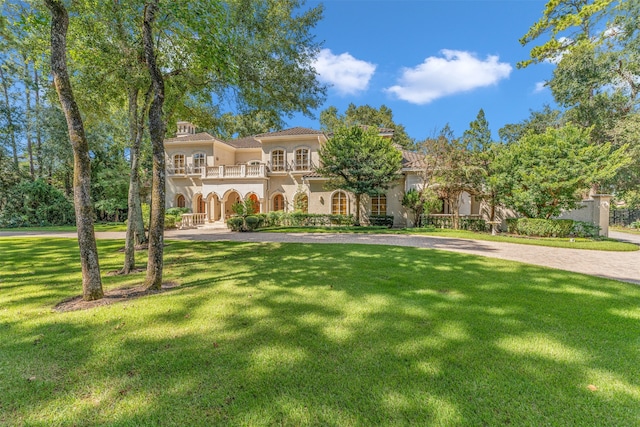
142, 0, 166, 289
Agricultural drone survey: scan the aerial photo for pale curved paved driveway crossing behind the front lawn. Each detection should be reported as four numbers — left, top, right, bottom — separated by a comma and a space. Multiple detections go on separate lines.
0, 228, 640, 284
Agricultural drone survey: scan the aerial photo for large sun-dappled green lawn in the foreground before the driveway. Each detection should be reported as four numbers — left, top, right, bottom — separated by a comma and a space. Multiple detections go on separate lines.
0, 238, 640, 426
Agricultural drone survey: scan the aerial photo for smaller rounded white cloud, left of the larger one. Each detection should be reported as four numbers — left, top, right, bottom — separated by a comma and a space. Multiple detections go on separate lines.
314, 49, 376, 95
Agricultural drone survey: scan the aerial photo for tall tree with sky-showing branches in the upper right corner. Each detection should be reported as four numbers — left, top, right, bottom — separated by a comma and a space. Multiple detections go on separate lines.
518, 0, 640, 196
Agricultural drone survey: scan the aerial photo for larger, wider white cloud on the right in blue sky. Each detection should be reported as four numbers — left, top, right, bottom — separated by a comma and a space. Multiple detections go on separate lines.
386, 49, 512, 104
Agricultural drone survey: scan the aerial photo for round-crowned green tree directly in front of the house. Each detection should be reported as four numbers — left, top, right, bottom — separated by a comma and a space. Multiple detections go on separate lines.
318, 126, 402, 224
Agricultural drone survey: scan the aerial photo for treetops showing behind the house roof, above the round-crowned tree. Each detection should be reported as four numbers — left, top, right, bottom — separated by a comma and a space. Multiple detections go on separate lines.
320, 104, 415, 148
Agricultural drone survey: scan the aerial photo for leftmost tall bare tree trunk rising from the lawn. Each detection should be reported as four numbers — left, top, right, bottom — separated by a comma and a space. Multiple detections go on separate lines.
45, 0, 104, 300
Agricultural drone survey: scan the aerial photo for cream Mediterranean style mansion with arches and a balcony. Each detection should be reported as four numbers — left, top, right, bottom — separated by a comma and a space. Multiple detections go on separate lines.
164, 122, 480, 227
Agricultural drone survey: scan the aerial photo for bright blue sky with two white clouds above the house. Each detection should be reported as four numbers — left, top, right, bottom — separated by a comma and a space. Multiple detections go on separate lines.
288, 0, 554, 140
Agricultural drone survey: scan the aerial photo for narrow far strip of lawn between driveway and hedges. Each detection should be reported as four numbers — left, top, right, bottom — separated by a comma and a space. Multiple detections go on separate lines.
258, 227, 640, 252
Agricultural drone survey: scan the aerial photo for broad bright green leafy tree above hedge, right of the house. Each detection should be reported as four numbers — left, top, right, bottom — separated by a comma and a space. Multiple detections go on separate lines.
495, 124, 629, 218
